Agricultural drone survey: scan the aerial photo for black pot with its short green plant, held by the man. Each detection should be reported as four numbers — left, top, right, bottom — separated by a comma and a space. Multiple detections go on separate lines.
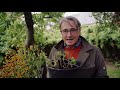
47, 51, 80, 78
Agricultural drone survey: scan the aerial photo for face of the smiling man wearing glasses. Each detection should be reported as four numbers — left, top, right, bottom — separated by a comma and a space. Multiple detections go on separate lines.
61, 20, 80, 47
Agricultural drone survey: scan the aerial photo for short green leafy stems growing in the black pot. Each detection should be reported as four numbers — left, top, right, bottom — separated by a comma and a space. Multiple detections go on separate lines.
46, 51, 77, 69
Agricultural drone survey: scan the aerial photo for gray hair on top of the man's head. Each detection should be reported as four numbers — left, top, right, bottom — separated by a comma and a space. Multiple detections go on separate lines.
59, 16, 81, 29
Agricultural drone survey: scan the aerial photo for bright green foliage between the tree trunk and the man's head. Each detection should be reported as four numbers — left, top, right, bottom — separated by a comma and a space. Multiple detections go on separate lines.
33, 12, 63, 47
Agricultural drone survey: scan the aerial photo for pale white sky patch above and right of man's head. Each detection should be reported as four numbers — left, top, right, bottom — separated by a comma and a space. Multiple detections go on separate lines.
64, 12, 96, 25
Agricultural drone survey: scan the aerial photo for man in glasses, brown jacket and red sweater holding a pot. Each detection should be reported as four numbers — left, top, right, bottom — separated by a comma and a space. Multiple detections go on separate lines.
49, 16, 108, 78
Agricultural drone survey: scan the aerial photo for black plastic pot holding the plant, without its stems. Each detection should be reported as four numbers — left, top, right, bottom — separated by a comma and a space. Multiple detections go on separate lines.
47, 65, 79, 78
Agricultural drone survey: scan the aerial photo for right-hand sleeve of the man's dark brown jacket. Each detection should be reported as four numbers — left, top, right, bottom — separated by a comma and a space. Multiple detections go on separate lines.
95, 48, 109, 78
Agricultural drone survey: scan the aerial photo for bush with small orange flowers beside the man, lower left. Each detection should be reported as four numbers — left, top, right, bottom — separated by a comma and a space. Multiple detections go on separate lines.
0, 45, 47, 78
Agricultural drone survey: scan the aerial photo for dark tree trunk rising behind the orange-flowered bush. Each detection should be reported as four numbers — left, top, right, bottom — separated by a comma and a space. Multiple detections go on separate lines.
24, 12, 34, 48
